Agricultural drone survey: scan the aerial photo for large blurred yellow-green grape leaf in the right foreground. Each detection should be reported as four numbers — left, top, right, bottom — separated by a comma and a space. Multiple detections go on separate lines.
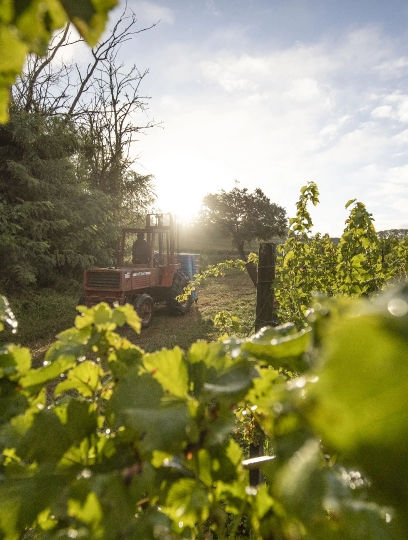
309, 294, 408, 512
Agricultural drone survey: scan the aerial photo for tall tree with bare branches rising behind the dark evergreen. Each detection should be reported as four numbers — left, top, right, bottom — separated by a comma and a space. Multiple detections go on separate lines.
12, 8, 154, 221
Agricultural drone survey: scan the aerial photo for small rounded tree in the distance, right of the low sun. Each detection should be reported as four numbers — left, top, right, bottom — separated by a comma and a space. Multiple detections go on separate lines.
201, 186, 287, 260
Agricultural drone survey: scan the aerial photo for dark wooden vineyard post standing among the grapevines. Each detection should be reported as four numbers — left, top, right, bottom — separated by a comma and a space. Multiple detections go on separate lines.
249, 242, 277, 486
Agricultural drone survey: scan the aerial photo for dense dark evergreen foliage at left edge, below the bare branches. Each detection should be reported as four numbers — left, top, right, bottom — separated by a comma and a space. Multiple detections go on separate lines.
0, 107, 116, 290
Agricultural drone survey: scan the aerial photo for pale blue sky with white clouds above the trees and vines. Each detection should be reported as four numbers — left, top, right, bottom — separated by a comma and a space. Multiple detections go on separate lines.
104, 0, 408, 236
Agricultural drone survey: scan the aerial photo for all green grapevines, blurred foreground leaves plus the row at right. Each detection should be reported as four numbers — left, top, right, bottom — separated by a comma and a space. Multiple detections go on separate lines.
0, 183, 408, 540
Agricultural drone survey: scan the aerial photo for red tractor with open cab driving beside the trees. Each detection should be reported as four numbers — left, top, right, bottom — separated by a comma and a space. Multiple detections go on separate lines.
84, 214, 193, 328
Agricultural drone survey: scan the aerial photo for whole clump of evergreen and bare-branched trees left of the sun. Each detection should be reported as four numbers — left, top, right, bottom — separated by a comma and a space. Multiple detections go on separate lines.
0, 7, 154, 291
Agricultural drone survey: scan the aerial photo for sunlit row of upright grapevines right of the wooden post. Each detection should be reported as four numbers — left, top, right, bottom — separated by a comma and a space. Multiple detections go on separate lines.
276, 182, 408, 327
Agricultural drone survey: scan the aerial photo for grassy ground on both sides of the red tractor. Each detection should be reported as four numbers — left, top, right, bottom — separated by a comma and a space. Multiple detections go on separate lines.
0, 270, 255, 359
